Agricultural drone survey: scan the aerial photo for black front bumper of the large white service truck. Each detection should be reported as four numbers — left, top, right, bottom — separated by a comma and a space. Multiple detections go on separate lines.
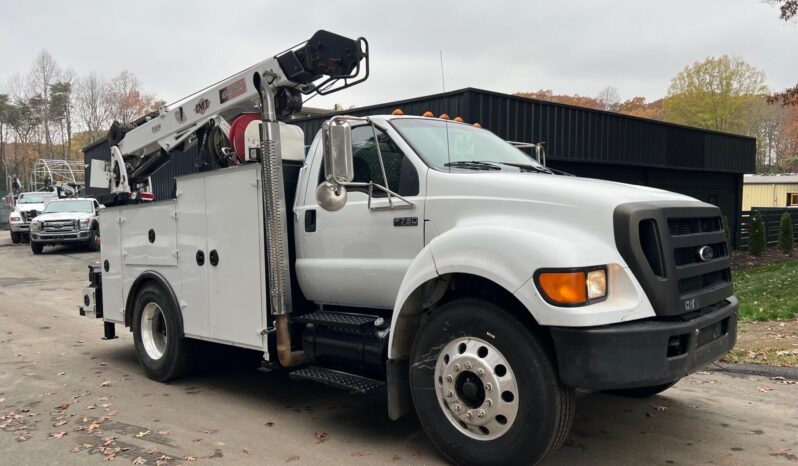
551, 297, 738, 390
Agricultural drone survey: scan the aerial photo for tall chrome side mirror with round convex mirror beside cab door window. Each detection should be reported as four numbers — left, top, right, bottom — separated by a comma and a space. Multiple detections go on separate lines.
316, 118, 355, 211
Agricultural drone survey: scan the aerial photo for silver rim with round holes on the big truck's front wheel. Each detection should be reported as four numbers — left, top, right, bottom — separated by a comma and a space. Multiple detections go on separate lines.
435, 337, 519, 441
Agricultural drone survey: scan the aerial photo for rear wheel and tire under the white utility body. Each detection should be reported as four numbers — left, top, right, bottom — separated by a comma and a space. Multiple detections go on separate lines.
131, 283, 193, 382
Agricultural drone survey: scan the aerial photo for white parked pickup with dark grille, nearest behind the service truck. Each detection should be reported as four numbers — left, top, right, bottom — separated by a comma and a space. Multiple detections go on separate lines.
30, 198, 103, 254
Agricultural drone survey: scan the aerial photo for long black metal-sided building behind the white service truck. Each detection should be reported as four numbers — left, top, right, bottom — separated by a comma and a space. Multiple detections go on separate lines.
84, 88, 756, 242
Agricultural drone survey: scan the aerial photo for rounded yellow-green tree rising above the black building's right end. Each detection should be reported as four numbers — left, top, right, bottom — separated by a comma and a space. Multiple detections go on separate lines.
663, 55, 768, 134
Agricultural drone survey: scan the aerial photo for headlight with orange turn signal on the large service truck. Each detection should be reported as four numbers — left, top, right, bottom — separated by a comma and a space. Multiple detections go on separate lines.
535, 266, 607, 307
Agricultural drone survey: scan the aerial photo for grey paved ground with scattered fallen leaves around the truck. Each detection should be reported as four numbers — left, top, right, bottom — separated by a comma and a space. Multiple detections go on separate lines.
0, 232, 798, 465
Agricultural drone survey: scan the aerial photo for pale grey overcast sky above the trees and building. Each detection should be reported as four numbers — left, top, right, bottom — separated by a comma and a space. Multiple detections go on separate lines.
0, 0, 798, 106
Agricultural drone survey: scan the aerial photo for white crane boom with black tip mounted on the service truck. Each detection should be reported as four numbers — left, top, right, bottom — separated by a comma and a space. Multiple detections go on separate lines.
101, 30, 369, 200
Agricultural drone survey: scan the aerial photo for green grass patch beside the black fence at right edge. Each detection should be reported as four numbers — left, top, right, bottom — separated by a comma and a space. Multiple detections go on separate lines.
734, 260, 798, 322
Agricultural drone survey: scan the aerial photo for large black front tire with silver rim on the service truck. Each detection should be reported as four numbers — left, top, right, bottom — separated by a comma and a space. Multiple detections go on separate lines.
410, 299, 574, 466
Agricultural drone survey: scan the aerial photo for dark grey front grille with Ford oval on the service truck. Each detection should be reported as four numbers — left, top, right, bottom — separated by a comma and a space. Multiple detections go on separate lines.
614, 203, 732, 316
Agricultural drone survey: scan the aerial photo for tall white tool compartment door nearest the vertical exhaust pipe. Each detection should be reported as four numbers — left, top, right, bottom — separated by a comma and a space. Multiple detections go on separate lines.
205, 164, 266, 349
